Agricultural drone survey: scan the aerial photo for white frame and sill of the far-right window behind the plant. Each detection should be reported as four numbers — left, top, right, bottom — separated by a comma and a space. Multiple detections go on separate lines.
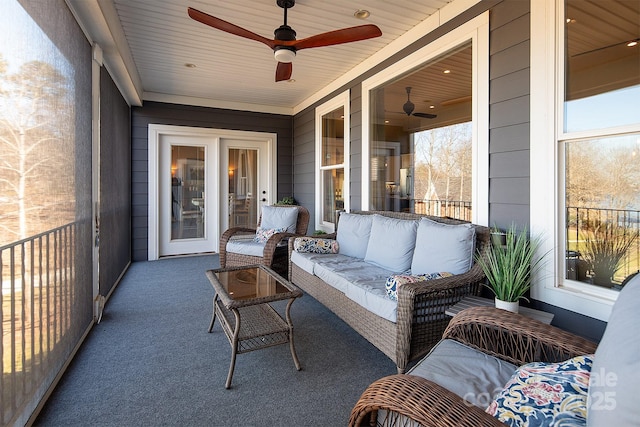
530, 0, 639, 321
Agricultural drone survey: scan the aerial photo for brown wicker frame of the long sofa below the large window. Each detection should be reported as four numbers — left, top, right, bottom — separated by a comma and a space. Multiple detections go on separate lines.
289, 211, 490, 373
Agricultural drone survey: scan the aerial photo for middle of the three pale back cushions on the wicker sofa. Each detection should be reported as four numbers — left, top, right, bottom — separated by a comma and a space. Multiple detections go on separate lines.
364, 215, 420, 273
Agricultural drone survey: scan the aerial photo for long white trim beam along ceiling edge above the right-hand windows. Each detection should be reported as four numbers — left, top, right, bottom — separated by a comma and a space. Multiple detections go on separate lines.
293, 0, 480, 114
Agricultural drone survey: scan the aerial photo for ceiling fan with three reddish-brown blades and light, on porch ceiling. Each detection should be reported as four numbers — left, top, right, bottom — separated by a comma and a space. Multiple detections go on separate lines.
187, 0, 382, 82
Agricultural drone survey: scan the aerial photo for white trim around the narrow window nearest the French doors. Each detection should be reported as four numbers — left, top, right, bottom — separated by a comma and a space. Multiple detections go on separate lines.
315, 90, 351, 233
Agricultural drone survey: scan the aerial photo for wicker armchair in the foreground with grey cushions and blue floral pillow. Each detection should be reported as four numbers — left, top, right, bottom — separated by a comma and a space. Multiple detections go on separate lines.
349, 274, 640, 427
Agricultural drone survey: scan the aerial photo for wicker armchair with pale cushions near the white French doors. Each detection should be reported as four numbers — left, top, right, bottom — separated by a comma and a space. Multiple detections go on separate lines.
219, 204, 309, 277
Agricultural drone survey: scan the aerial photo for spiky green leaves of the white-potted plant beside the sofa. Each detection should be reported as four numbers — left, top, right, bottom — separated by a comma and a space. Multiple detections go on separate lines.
476, 225, 543, 302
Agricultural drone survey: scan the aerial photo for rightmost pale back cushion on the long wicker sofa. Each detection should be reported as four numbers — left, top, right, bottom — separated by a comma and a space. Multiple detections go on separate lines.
411, 218, 476, 274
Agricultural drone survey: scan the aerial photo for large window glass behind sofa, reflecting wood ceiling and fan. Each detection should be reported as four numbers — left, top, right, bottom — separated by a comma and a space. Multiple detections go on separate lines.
369, 42, 473, 220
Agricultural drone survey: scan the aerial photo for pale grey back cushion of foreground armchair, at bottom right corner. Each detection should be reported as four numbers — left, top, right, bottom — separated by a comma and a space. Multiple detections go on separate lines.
587, 274, 640, 426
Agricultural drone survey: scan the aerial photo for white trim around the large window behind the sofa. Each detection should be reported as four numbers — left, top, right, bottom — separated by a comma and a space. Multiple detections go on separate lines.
362, 12, 489, 225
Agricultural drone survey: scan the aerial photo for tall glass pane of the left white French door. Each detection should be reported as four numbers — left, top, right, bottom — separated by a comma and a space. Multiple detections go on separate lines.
171, 145, 205, 240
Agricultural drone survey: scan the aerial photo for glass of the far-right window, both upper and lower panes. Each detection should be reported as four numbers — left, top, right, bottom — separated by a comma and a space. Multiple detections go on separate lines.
559, 0, 640, 290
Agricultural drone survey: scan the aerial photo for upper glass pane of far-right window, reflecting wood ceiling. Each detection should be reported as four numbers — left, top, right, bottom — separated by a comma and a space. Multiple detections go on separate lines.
564, 0, 640, 132
